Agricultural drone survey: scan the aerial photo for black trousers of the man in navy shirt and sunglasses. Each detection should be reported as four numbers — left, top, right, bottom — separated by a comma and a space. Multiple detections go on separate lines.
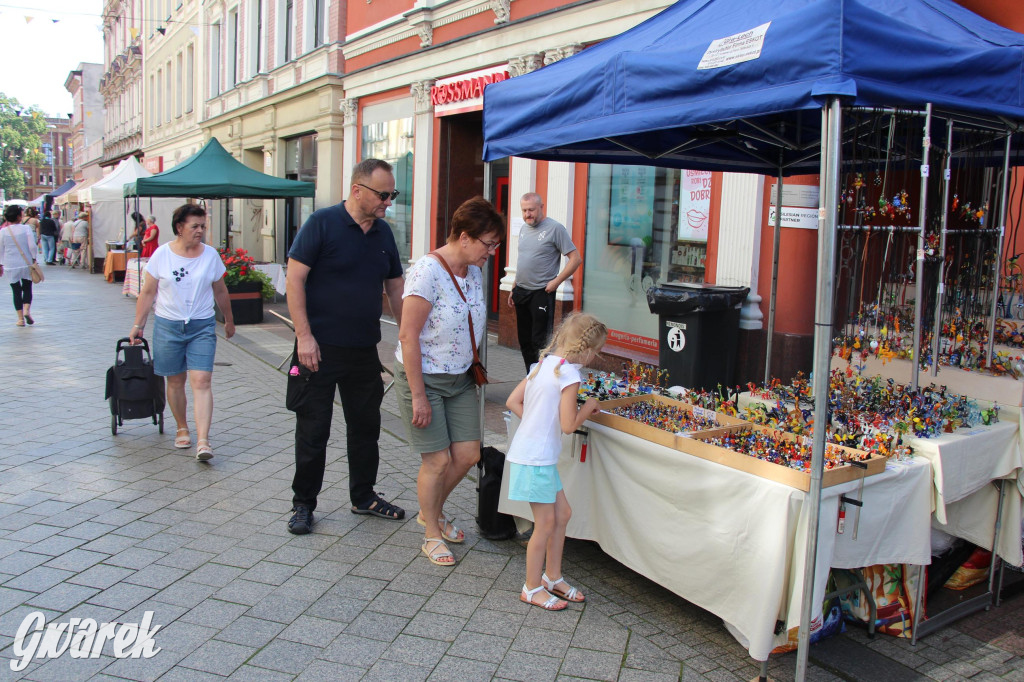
292, 345, 384, 509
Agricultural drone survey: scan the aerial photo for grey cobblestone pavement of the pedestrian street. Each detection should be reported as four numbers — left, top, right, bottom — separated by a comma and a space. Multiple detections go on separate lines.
0, 267, 1024, 681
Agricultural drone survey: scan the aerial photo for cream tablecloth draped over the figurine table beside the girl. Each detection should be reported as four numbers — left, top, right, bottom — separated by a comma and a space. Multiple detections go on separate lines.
499, 423, 931, 660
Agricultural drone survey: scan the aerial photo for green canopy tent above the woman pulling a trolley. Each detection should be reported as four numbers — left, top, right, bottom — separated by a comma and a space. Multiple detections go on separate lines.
124, 137, 316, 286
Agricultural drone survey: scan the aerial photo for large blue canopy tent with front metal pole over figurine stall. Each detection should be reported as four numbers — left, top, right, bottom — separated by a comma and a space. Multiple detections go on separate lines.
483, 0, 1024, 680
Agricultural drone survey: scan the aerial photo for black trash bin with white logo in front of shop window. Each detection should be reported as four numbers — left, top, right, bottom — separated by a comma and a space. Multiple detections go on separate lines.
647, 284, 751, 390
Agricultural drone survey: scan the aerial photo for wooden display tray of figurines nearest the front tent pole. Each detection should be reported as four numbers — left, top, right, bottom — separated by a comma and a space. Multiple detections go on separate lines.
678, 424, 888, 493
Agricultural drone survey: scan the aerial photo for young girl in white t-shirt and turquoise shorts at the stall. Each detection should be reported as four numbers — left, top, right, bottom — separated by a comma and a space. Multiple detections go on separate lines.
505, 312, 608, 611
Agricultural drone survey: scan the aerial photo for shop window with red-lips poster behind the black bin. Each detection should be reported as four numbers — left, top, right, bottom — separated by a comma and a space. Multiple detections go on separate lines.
583, 164, 710, 339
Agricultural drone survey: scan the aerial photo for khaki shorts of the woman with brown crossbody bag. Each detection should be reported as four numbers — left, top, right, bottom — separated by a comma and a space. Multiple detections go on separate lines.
394, 363, 480, 455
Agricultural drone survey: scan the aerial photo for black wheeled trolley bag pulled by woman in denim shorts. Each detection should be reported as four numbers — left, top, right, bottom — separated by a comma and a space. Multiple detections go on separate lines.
103, 338, 165, 435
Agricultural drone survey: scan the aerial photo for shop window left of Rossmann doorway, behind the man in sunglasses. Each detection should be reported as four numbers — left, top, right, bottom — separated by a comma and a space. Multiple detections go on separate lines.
361, 116, 414, 261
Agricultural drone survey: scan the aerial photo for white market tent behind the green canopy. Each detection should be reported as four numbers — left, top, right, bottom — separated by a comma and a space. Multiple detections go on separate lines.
84, 157, 184, 245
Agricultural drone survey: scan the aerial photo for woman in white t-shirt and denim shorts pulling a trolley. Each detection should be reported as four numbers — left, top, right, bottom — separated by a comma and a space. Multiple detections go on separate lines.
128, 204, 234, 462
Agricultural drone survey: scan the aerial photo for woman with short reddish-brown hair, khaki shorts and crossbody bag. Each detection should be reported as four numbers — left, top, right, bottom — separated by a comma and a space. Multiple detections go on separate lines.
394, 197, 505, 566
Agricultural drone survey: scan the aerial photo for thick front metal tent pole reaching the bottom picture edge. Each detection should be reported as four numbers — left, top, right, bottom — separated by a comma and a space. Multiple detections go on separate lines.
796, 97, 843, 682
